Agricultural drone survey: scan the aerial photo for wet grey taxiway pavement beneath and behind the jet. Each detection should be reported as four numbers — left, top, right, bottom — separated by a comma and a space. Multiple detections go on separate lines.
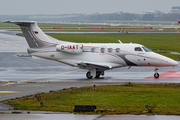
0, 33, 180, 119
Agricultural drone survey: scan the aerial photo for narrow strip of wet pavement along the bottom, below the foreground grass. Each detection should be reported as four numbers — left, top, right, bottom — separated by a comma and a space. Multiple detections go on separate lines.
1, 114, 179, 120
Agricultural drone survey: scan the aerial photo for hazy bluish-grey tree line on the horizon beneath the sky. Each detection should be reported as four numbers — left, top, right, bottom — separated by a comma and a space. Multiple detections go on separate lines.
0, 13, 180, 21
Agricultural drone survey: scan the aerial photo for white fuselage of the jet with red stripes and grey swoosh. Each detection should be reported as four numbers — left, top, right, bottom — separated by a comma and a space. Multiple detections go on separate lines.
32, 43, 178, 68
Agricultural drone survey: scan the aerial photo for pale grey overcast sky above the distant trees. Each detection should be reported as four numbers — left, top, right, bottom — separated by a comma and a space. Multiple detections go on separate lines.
0, 0, 180, 15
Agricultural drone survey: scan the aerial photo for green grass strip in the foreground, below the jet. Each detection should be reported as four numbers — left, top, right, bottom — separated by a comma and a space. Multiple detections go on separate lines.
4, 84, 180, 115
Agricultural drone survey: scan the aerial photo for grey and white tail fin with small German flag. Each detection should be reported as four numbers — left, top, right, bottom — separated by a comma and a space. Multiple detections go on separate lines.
5, 21, 56, 48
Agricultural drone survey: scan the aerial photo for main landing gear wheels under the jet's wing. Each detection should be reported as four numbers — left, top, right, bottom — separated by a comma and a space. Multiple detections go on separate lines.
86, 70, 104, 79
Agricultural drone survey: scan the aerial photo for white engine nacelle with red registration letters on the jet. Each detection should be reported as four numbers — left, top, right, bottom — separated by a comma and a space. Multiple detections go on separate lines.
56, 44, 83, 54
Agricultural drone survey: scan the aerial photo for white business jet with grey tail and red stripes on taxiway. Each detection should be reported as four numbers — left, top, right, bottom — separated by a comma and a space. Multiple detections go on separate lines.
5, 21, 178, 79
